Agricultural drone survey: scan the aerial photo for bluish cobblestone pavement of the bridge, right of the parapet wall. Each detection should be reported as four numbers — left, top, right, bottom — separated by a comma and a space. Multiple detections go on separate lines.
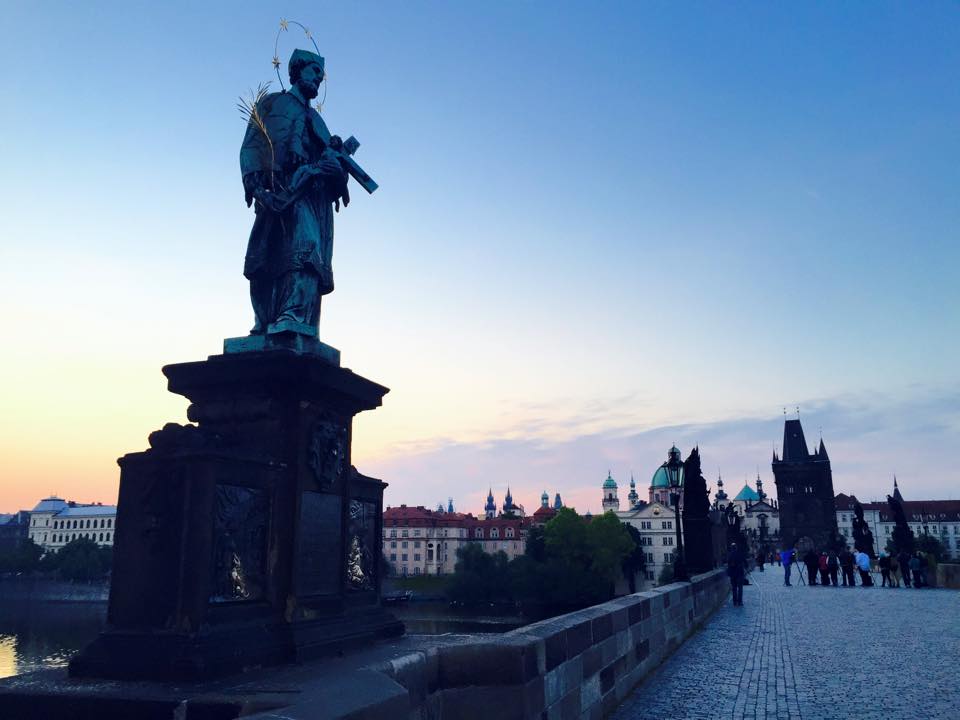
613, 566, 960, 720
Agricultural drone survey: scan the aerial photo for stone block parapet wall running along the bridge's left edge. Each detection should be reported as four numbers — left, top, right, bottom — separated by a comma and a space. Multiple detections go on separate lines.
368, 570, 729, 720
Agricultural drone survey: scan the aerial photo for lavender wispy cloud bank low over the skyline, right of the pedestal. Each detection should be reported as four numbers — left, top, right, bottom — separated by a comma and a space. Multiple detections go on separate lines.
361, 388, 960, 512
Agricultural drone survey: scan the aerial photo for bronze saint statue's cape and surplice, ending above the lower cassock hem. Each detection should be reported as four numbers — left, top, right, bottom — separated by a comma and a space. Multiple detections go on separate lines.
240, 89, 335, 295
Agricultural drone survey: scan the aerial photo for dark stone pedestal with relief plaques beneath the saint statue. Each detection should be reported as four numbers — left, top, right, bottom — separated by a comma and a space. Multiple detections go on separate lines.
70, 347, 403, 680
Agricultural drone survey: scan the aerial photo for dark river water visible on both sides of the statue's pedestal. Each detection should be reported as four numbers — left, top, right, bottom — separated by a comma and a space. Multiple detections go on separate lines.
0, 594, 522, 677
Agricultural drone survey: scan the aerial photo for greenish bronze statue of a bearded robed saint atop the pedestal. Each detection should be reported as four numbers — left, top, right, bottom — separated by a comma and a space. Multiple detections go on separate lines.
240, 50, 350, 337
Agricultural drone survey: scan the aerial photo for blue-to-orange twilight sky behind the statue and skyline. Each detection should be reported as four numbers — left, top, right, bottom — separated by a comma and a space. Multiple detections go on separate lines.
0, 1, 960, 512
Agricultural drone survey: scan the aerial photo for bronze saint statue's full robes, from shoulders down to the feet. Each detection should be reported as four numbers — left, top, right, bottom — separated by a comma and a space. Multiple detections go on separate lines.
240, 87, 346, 332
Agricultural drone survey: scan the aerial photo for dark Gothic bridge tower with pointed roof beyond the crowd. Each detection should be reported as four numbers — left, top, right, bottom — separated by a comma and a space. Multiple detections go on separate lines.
773, 418, 837, 550
